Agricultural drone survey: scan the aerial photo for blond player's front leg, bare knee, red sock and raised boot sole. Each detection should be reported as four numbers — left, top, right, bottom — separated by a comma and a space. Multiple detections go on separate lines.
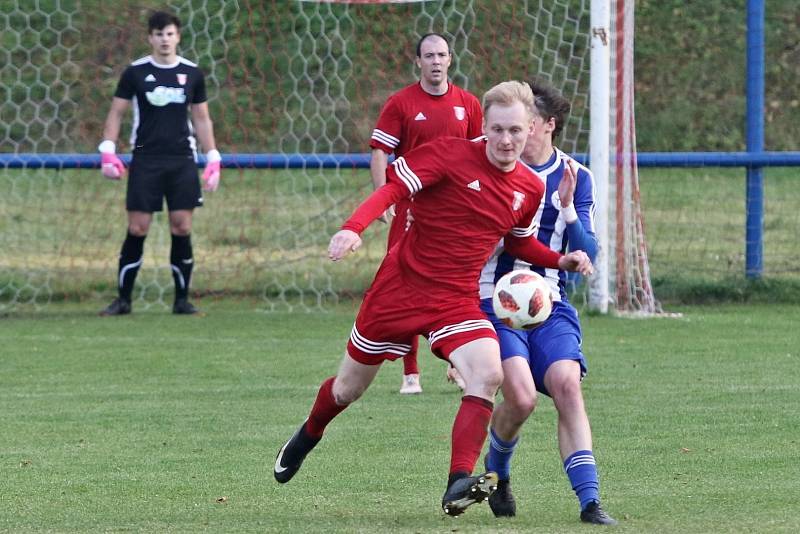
442, 338, 503, 515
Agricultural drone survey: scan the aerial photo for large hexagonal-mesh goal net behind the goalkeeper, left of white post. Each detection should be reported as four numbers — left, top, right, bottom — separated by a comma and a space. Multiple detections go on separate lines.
0, 0, 639, 310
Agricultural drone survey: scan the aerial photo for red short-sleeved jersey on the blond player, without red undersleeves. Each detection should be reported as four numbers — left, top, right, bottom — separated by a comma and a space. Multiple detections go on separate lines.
372, 137, 544, 295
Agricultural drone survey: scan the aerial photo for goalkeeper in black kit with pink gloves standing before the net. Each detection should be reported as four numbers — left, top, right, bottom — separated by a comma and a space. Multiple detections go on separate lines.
98, 11, 222, 316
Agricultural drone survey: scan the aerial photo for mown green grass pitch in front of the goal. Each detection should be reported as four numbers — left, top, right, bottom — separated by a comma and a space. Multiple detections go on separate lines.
0, 299, 800, 533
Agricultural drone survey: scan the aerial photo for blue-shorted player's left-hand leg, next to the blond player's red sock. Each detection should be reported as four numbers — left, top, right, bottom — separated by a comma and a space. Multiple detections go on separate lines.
486, 356, 536, 517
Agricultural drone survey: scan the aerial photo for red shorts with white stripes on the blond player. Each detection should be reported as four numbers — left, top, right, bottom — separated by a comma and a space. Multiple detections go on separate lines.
347, 254, 497, 365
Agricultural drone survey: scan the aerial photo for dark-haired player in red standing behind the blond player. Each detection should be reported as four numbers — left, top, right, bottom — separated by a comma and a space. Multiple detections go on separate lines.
369, 33, 483, 394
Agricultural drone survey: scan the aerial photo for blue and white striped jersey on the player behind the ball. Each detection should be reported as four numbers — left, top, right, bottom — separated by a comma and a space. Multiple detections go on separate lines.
480, 148, 597, 301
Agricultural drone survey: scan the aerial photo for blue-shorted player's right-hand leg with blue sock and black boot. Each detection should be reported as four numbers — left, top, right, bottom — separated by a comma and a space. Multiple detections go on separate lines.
544, 360, 616, 524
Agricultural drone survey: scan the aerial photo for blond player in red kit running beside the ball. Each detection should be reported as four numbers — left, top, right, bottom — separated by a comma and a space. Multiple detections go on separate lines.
274, 82, 592, 515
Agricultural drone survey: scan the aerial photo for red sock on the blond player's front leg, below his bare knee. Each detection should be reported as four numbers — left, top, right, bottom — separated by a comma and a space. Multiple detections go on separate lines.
450, 395, 494, 474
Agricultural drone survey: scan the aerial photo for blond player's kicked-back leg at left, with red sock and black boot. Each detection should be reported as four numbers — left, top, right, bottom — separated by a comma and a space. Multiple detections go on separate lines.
274, 354, 380, 484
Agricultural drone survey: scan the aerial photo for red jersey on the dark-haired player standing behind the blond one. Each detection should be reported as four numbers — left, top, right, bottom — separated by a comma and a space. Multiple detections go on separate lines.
369, 82, 483, 157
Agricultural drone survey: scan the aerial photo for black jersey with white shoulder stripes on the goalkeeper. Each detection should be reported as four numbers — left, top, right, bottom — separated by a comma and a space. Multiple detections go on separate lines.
114, 56, 211, 156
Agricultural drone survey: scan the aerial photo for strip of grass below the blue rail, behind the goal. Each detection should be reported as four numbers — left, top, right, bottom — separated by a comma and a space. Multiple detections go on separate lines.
0, 168, 800, 309
